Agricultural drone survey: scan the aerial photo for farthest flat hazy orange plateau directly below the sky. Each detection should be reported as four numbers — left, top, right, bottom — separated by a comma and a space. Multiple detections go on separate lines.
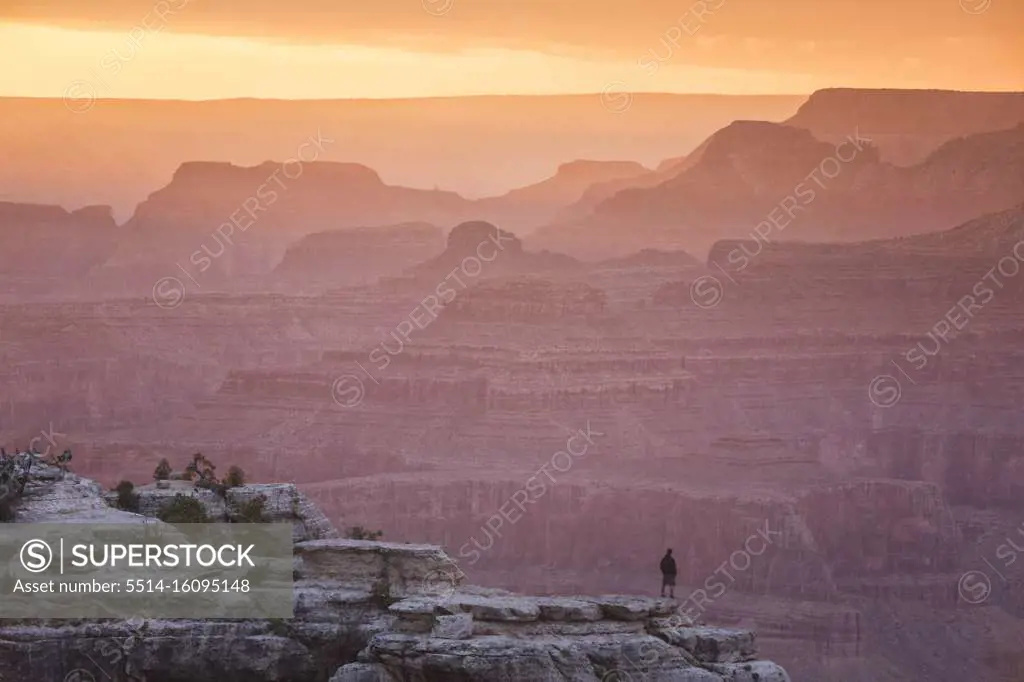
0, 93, 806, 220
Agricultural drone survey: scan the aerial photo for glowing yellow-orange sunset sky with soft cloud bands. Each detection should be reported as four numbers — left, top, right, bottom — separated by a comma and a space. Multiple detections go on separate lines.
0, 0, 1024, 98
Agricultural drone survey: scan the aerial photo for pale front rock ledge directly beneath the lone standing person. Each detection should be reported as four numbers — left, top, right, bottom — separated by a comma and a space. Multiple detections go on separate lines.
332, 592, 790, 682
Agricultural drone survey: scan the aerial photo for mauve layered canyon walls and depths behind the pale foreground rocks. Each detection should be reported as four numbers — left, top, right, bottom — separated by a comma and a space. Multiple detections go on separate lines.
6, 211, 1024, 682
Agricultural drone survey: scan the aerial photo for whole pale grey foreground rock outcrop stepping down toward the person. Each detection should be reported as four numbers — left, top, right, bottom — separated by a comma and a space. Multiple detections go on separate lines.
0, 467, 790, 682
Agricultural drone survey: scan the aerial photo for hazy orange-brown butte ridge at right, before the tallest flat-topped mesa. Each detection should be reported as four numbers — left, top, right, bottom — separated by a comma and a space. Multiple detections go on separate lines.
527, 121, 1024, 259
